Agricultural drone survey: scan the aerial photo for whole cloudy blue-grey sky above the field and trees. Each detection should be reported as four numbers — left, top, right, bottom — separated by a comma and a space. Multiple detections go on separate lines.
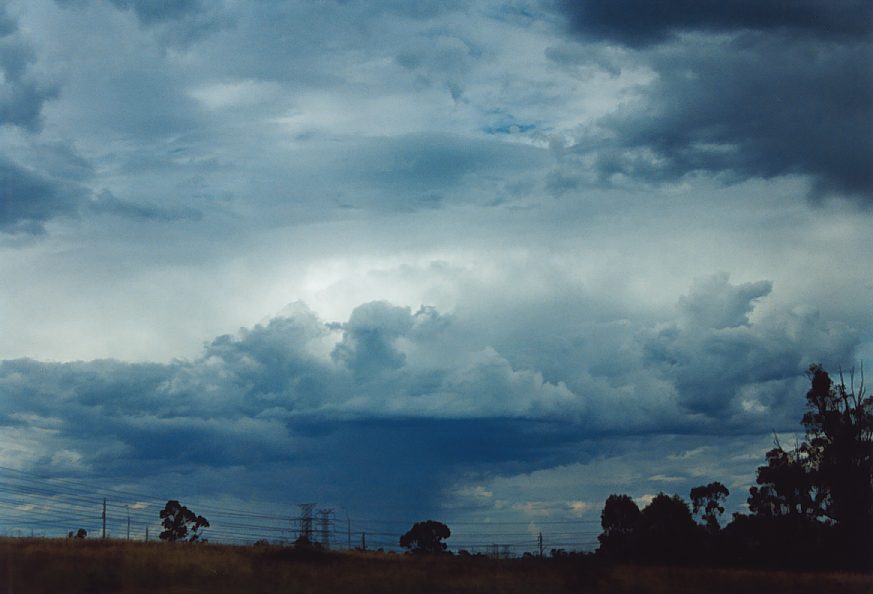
0, 0, 873, 538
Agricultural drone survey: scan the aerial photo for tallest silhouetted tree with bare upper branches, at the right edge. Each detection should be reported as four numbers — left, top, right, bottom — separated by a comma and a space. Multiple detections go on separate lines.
734, 364, 873, 569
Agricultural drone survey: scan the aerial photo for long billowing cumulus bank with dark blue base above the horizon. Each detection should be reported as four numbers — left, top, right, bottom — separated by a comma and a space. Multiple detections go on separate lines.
0, 275, 856, 515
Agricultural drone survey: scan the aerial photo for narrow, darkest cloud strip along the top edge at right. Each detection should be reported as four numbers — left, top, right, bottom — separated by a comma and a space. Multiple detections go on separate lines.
562, 0, 873, 47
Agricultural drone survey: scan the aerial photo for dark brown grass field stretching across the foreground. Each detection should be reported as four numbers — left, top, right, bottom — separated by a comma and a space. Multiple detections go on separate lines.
0, 539, 873, 594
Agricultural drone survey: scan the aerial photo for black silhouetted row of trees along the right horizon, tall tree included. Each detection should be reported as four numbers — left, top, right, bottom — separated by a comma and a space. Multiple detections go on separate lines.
598, 365, 873, 569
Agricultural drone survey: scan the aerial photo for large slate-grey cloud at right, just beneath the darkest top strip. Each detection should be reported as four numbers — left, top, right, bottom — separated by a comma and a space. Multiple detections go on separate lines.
554, 34, 873, 203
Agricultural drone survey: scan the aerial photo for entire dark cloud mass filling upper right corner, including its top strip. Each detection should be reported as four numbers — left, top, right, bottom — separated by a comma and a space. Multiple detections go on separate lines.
552, 2, 873, 203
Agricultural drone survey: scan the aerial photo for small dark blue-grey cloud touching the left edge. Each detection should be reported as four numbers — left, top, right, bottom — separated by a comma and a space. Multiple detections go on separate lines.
0, 156, 87, 235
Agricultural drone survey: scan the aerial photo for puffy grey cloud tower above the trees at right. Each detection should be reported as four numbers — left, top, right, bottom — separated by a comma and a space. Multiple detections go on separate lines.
641, 275, 858, 416
